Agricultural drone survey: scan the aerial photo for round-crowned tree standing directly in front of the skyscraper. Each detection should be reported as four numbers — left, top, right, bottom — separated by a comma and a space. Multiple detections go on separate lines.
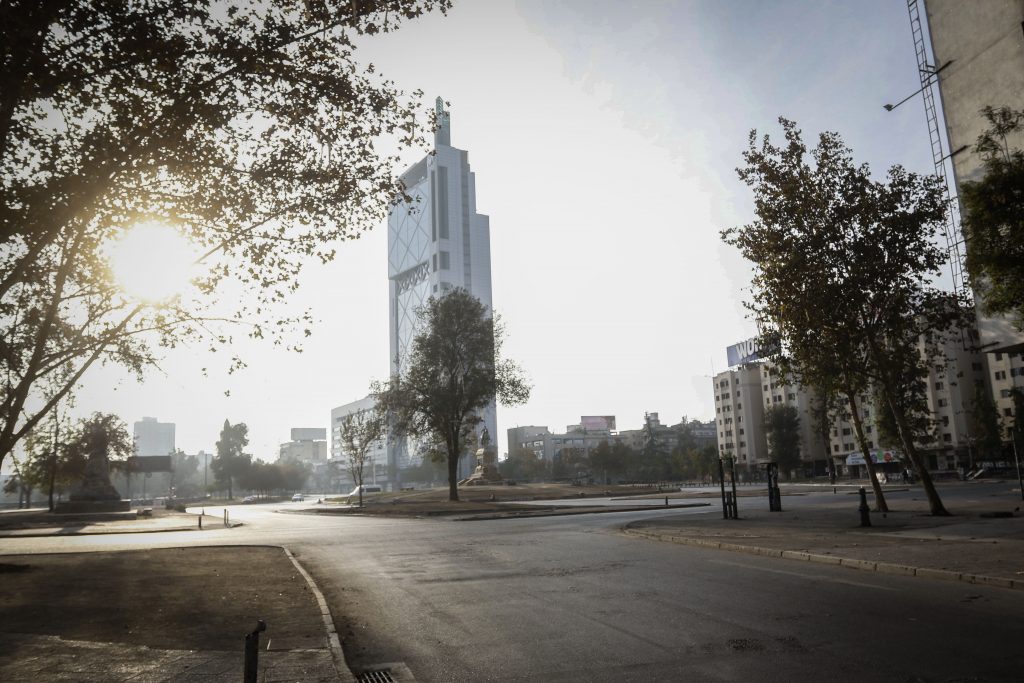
372, 288, 529, 501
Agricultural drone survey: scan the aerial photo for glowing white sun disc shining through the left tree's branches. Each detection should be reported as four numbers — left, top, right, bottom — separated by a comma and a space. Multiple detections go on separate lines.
108, 221, 199, 304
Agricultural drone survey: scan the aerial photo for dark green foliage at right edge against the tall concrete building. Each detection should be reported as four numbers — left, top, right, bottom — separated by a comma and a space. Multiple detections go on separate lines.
961, 106, 1024, 329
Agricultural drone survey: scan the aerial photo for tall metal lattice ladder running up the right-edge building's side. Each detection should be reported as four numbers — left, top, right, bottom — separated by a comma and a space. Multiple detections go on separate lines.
906, 0, 971, 297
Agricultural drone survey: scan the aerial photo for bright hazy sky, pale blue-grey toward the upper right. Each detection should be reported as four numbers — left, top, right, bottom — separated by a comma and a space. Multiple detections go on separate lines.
59, 0, 931, 461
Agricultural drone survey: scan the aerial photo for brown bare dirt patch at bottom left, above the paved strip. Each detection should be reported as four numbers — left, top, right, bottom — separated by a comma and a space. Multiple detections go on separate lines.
0, 547, 325, 651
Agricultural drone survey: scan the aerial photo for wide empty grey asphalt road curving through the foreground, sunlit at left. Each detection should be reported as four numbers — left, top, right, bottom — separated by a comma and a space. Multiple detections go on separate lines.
0, 489, 1024, 681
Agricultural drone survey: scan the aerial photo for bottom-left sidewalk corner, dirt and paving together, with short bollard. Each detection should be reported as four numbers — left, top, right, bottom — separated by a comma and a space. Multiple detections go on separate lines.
0, 546, 354, 683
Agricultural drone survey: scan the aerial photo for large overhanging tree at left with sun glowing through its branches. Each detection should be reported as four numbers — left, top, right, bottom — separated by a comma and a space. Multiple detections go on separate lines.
0, 0, 451, 471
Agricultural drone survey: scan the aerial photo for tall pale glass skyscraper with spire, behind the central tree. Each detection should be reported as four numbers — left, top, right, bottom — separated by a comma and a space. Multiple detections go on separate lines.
388, 97, 498, 472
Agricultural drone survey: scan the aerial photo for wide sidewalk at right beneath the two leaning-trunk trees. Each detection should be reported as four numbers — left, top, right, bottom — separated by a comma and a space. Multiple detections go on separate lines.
624, 487, 1024, 589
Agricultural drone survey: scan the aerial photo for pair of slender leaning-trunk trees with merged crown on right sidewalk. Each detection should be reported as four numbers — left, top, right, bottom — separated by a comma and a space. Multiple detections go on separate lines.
722, 119, 965, 515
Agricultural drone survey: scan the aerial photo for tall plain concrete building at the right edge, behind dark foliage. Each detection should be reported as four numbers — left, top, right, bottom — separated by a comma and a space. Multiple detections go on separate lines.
910, 0, 1024, 438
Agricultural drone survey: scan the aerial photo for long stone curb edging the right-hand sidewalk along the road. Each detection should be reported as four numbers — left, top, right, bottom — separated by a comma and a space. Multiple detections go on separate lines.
622, 526, 1024, 590
